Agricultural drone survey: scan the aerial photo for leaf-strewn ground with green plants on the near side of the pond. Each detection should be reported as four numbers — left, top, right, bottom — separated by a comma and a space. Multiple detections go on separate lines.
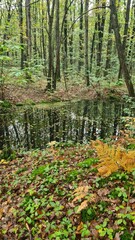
0, 138, 135, 240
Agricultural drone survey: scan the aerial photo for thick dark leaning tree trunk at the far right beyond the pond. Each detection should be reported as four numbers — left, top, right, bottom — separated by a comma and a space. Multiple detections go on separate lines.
110, 0, 135, 97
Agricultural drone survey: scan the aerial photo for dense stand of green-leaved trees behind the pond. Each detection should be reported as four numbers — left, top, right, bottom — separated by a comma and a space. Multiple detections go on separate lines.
0, 0, 135, 97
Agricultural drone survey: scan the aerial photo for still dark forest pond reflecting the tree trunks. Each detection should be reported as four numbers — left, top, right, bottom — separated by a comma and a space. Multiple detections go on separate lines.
0, 100, 133, 150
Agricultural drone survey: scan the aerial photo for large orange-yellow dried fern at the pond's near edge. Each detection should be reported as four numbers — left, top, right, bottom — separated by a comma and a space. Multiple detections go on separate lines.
92, 140, 135, 177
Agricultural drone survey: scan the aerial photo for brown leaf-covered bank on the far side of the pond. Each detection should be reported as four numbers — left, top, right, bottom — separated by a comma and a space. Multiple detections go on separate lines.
1, 81, 127, 104
